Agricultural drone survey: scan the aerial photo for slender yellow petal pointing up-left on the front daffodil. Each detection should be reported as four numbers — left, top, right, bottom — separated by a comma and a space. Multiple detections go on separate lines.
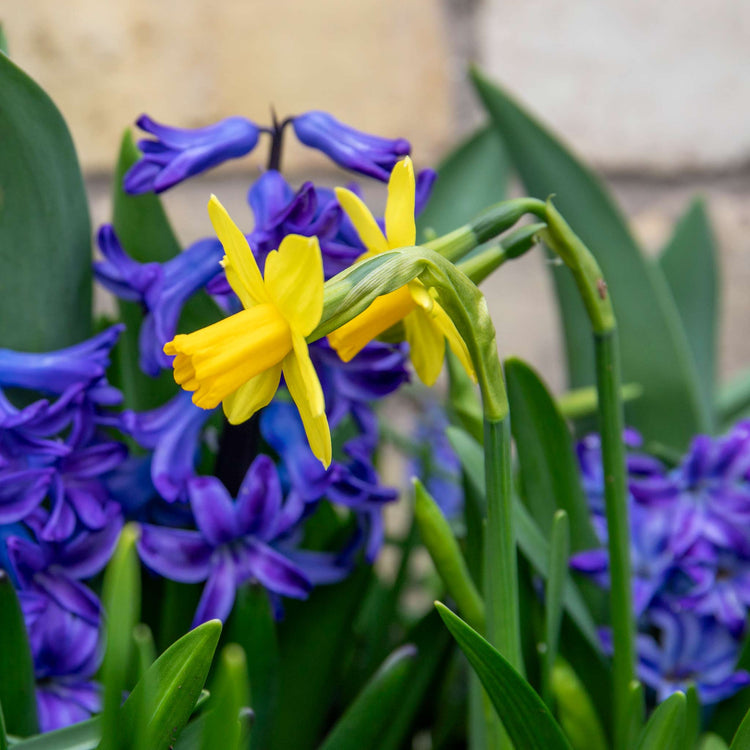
208, 195, 270, 307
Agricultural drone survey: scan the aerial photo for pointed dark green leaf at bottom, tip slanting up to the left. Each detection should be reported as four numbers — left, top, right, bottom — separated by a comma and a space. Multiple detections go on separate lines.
435, 602, 570, 750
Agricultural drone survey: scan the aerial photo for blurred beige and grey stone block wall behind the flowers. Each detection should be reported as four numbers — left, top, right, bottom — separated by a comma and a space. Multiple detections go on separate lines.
0, 0, 750, 394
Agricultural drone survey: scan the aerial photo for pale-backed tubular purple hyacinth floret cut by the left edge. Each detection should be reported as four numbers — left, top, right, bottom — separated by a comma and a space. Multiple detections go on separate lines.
0, 325, 125, 395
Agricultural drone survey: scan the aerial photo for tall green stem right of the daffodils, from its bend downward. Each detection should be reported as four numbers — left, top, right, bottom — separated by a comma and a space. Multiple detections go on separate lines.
541, 203, 635, 748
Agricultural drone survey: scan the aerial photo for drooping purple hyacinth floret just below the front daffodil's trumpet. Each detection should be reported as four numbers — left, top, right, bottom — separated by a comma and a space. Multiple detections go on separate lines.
122, 391, 215, 502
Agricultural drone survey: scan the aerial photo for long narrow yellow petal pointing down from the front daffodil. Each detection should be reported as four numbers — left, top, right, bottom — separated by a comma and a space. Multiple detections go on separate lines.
282, 334, 332, 468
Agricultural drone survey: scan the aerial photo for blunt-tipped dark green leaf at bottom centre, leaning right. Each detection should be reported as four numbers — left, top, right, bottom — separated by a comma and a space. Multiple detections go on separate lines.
320, 645, 416, 750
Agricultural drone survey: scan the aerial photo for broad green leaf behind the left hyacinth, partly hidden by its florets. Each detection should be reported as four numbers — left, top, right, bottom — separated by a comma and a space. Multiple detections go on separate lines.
112, 129, 221, 409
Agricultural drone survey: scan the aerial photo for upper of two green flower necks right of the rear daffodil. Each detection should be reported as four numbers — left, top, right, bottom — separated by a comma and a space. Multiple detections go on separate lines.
423, 198, 546, 261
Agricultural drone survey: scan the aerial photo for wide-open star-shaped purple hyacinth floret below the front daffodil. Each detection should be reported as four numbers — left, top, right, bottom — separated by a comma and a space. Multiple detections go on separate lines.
138, 455, 324, 625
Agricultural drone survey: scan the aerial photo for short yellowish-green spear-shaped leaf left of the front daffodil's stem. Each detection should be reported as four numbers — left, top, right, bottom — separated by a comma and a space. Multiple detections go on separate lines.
413, 478, 485, 630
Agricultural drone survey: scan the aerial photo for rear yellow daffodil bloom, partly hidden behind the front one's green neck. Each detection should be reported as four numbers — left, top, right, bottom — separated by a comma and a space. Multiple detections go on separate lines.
328, 156, 475, 385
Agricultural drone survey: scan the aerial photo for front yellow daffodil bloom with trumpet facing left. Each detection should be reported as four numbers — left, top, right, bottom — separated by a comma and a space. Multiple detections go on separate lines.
164, 200, 331, 466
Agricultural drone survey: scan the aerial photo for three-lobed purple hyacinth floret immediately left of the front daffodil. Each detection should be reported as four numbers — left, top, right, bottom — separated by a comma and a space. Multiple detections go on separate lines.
94, 224, 224, 377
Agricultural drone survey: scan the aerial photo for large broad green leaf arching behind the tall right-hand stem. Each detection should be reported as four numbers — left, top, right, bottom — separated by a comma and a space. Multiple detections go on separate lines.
472, 70, 710, 448
